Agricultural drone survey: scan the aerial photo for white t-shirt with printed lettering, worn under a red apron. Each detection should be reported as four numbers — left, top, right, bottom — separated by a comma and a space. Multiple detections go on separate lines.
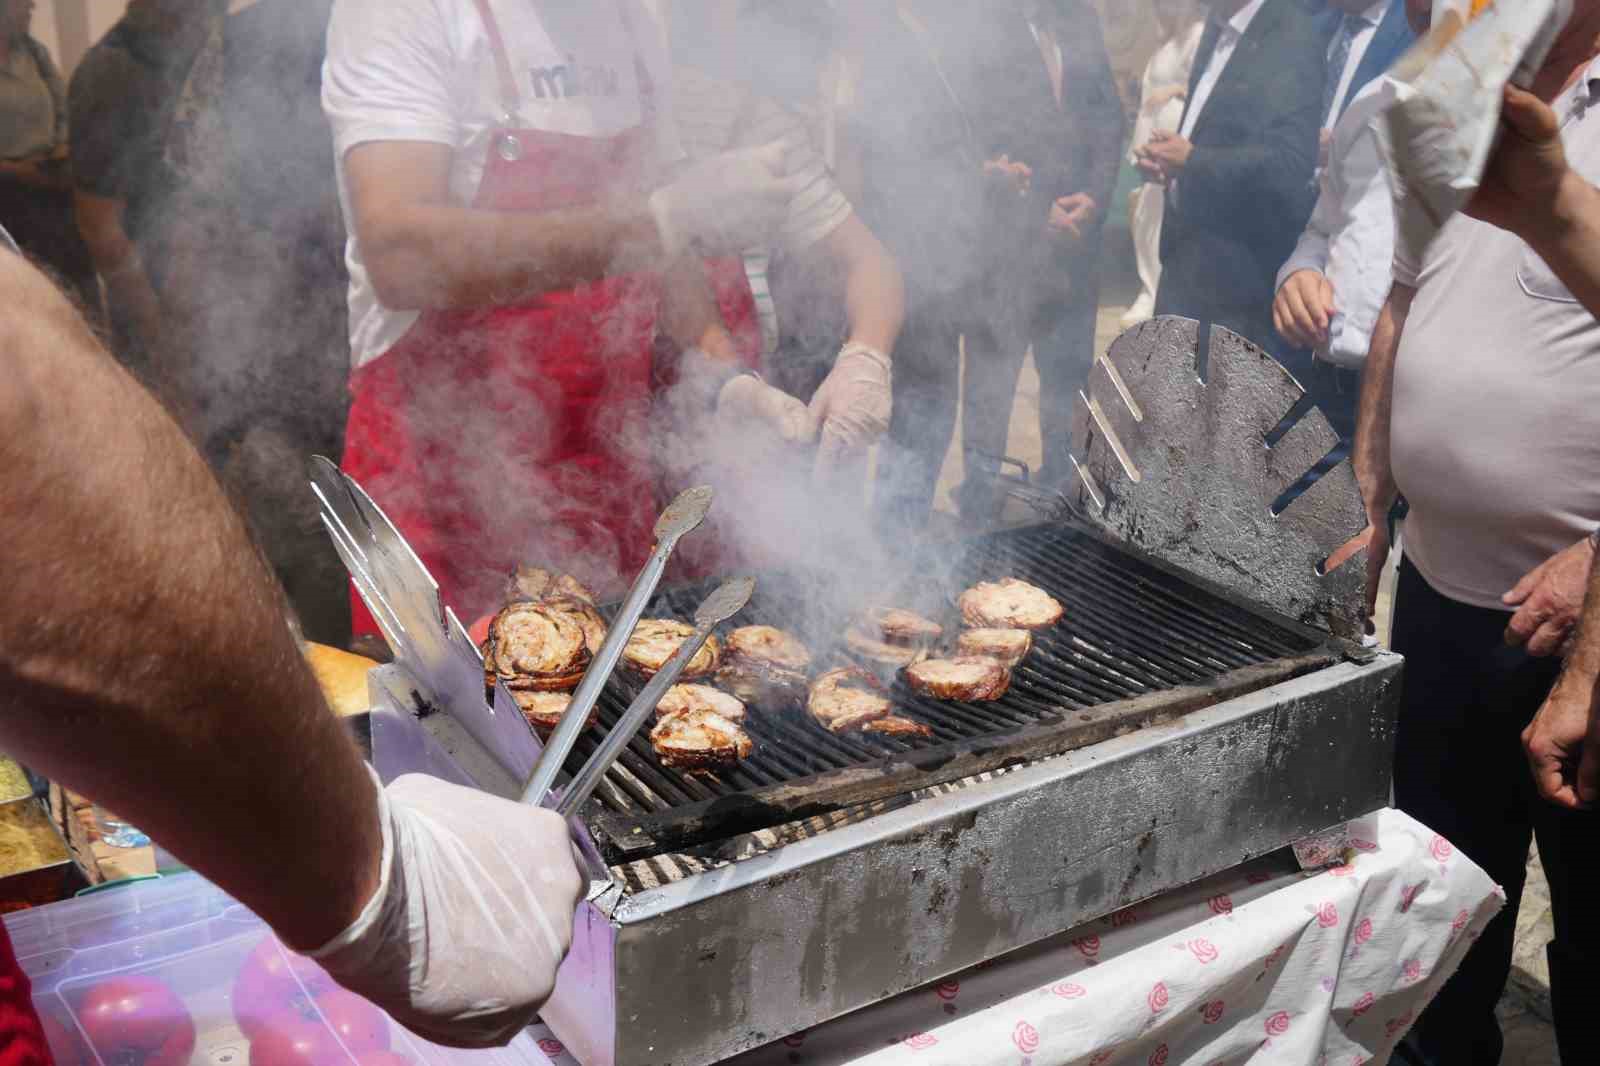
322, 0, 680, 367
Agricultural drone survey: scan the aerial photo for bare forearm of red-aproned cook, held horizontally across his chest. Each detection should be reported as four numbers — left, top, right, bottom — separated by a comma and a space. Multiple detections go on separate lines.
363, 203, 661, 311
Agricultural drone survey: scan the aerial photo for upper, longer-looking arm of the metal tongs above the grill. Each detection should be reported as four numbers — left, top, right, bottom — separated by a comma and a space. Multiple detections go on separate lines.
522, 485, 714, 807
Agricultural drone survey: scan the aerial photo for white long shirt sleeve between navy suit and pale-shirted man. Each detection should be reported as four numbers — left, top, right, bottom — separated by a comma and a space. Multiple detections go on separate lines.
1278, 82, 1395, 370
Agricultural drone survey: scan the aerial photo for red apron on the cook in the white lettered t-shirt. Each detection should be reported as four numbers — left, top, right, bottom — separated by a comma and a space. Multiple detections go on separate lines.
344, 0, 658, 632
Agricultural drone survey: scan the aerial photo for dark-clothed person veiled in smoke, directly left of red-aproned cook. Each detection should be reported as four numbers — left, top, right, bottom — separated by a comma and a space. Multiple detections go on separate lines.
160, 0, 350, 647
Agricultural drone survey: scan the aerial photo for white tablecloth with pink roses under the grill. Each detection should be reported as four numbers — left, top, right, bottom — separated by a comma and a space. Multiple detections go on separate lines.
533, 810, 1504, 1066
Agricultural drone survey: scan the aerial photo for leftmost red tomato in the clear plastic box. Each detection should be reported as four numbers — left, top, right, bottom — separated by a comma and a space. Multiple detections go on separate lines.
78, 976, 195, 1066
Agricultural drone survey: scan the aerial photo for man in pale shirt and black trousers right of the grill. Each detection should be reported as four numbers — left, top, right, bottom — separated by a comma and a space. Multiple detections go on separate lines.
1355, 0, 1600, 1066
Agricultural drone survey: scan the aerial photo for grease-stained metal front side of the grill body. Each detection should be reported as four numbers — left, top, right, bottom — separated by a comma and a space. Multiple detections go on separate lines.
542, 656, 1400, 1066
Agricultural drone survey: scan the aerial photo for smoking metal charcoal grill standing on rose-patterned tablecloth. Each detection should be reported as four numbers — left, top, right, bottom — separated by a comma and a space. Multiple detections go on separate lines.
317, 320, 1400, 1066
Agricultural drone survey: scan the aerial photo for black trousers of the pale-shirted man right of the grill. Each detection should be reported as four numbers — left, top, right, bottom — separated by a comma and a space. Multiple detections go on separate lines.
1394, 562, 1600, 1066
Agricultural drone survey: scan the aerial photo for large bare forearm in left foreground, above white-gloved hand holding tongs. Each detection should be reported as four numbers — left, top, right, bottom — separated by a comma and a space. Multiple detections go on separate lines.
0, 256, 381, 948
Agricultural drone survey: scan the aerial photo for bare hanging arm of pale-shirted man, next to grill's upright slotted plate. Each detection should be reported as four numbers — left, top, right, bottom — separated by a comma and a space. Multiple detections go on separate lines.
1354, 282, 1416, 618
